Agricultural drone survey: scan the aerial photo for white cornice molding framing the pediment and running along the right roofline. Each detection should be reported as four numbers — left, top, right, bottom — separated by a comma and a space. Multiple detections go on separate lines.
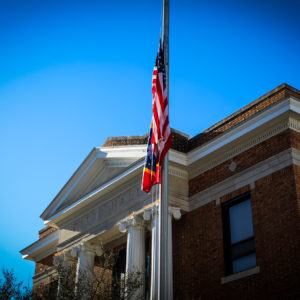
42, 96, 300, 230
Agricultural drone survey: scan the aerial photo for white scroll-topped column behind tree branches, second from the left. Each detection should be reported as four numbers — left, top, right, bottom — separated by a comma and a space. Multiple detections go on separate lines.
71, 242, 103, 296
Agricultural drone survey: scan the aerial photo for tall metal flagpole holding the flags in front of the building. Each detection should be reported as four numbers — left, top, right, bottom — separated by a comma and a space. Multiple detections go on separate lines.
158, 0, 171, 300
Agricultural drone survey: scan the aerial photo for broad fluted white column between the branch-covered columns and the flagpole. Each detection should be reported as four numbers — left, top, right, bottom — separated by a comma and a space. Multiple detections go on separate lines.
119, 215, 146, 297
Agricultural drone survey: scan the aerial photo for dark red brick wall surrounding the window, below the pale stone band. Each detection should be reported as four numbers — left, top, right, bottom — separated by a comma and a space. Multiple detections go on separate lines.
173, 166, 300, 300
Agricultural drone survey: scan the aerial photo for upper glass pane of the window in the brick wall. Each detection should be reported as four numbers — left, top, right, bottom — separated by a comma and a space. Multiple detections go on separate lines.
229, 199, 253, 244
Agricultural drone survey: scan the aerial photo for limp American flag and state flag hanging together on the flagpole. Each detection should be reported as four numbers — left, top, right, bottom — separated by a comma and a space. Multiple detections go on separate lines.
142, 43, 172, 193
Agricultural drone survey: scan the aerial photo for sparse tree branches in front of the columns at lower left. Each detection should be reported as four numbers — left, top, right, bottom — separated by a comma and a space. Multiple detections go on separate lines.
0, 251, 144, 300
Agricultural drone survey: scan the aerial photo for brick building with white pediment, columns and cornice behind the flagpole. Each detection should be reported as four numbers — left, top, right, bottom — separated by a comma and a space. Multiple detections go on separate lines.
21, 84, 300, 299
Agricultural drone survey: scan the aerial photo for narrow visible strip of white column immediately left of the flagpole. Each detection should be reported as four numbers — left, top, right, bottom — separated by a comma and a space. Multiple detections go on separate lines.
144, 205, 159, 300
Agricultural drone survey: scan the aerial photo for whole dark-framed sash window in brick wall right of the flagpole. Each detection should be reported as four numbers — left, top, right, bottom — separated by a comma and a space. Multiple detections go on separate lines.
222, 193, 256, 275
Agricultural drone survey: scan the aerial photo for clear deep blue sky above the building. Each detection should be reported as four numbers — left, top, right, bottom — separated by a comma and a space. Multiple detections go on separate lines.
0, 0, 300, 282
